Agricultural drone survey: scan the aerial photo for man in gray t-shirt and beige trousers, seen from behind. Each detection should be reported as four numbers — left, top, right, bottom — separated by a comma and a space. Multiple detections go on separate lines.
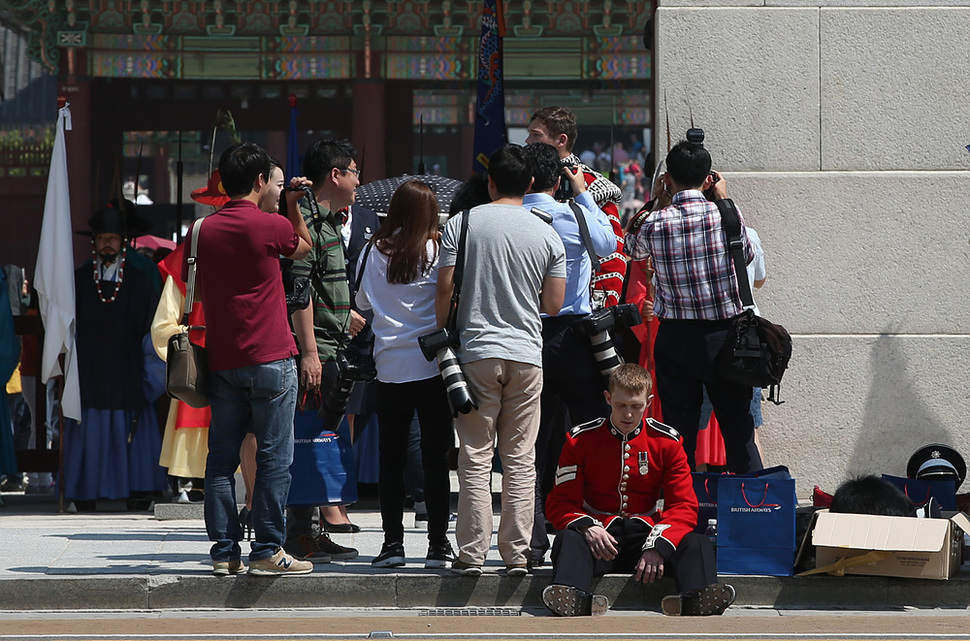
436, 145, 566, 576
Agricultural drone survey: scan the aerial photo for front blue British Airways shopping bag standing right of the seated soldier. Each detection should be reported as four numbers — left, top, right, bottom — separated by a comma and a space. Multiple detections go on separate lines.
717, 476, 797, 576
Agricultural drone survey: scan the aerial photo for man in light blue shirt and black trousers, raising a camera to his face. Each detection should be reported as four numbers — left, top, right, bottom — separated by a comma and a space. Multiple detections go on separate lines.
522, 143, 616, 567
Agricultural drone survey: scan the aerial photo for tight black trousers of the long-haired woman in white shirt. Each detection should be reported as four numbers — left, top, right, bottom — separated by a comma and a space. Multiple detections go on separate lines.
377, 376, 455, 544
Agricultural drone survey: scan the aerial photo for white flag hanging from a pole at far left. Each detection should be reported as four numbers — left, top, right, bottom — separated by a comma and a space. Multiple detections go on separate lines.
34, 105, 81, 421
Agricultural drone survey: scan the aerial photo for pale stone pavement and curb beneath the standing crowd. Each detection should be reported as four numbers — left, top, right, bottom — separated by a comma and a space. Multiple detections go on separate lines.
0, 494, 970, 614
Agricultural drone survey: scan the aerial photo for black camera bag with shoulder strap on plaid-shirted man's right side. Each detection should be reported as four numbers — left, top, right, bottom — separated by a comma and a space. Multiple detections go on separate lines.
717, 198, 791, 405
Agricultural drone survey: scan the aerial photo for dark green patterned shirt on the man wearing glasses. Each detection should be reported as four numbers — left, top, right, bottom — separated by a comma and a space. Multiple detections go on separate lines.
293, 206, 350, 362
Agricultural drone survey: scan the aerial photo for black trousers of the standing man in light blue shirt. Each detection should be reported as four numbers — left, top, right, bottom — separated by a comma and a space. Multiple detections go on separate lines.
531, 315, 610, 556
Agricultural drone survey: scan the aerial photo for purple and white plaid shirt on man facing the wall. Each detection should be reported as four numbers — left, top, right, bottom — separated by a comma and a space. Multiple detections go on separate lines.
631, 189, 754, 320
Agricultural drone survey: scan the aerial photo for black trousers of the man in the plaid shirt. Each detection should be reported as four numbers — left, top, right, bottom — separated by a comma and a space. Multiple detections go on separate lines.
653, 320, 762, 474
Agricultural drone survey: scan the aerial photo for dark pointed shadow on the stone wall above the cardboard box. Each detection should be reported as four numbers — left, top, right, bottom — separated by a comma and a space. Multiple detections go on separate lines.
847, 334, 953, 476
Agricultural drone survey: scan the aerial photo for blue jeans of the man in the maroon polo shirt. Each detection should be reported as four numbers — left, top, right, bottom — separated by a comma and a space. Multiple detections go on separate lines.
205, 358, 296, 561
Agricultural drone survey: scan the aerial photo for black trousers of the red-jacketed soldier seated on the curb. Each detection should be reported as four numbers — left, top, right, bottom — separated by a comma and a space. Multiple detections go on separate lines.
552, 519, 717, 592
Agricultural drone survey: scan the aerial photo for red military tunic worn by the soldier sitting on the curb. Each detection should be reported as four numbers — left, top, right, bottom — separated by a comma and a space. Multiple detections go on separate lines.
546, 418, 697, 560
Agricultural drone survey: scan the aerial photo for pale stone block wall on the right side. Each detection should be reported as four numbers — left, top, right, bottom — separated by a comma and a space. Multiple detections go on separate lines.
655, 0, 970, 498
